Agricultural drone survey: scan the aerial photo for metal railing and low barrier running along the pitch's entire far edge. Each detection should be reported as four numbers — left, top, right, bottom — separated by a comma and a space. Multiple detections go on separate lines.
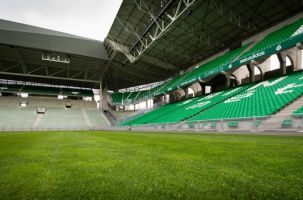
0, 115, 303, 132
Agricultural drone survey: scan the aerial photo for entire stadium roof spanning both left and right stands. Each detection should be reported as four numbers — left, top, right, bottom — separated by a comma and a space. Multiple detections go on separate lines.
0, 0, 303, 90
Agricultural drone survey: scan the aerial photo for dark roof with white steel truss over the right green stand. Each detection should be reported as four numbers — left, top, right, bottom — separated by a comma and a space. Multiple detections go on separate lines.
104, 0, 303, 88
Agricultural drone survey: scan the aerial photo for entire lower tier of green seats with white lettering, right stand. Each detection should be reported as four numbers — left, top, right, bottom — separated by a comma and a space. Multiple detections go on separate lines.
124, 71, 303, 125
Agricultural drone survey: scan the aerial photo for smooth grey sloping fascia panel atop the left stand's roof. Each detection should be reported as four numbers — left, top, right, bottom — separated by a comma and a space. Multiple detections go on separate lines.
0, 20, 108, 60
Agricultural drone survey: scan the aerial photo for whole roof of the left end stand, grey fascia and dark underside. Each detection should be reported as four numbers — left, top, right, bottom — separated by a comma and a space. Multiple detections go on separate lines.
0, 20, 171, 90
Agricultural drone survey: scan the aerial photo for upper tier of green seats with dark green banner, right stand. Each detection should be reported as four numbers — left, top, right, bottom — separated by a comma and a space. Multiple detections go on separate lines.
112, 18, 303, 104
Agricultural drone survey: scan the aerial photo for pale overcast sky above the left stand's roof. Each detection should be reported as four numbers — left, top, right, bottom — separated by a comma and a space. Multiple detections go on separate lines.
0, 0, 122, 41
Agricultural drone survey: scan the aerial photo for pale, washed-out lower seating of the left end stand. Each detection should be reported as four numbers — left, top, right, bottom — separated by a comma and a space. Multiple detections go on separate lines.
0, 96, 109, 130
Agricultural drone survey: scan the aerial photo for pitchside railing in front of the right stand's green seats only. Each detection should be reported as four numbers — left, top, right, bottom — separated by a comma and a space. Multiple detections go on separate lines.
121, 115, 303, 132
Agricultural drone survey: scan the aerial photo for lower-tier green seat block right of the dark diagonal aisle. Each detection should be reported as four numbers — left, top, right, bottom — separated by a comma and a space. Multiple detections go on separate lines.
189, 71, 303, 121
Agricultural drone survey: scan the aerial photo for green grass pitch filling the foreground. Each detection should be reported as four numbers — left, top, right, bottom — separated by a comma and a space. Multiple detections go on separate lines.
0, 131, 303, 200
